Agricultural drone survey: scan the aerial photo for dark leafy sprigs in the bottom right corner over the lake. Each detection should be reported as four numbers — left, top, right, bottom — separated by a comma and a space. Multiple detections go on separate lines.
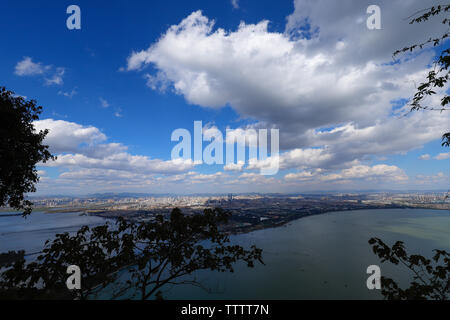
369, 238, 450, 300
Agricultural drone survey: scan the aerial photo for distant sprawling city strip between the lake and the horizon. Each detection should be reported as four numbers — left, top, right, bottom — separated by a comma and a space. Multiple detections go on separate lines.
6, 192, 442, 232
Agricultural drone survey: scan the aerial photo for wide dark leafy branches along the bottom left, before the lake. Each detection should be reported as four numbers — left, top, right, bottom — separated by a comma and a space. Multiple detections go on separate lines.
0, 209, 263, 299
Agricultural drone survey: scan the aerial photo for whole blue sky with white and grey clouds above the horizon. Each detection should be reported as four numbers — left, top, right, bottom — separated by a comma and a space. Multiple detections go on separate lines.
0, 0, 450, 194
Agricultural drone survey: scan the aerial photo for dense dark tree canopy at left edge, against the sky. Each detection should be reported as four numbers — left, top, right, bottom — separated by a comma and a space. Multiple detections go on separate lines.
0, 87, 54, 215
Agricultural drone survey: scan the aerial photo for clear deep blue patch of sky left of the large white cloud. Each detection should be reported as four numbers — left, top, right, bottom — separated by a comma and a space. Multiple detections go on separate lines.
0, 1, 293, 158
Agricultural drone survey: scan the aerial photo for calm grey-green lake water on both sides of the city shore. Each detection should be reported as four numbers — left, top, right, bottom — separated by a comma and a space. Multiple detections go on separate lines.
0, 209, 450, 299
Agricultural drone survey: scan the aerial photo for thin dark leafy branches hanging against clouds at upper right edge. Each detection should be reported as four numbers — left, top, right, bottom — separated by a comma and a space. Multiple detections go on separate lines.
394, 4, 450, 147
